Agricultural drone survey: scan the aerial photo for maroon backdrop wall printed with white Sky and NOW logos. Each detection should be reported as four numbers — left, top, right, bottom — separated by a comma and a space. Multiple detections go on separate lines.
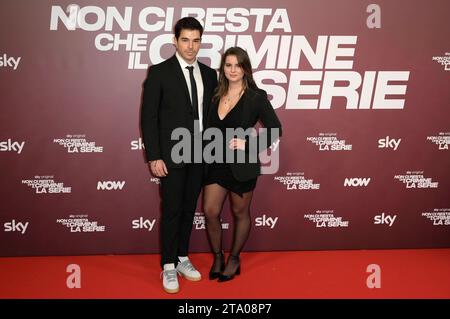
0, 0, 450, 256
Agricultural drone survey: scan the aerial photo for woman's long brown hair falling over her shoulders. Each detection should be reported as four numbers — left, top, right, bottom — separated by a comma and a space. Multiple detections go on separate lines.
213, 47, 258, 101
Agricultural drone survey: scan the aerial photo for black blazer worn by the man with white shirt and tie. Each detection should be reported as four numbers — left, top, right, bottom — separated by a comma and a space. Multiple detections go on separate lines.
141, 55, 217, 167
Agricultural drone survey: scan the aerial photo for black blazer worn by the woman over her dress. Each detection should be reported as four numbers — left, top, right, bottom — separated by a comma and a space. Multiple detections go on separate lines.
206, 88, 282, 181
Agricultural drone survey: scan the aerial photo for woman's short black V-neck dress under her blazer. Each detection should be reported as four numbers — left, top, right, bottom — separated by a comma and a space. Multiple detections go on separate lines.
204, 93, 257, 197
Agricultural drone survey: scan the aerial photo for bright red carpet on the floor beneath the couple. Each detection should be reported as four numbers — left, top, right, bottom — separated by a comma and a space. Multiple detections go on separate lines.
0, 249, 450, 299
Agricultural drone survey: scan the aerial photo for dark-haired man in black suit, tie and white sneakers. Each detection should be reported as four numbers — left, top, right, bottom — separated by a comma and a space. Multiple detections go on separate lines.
141, 17, 217, 293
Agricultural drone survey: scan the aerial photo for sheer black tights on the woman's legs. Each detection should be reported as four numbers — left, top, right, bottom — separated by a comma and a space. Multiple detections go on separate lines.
203, 184, 253, 275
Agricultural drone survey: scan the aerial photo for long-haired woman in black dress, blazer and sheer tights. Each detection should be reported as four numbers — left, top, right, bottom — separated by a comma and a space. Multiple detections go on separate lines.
203, 47, 281, 282
